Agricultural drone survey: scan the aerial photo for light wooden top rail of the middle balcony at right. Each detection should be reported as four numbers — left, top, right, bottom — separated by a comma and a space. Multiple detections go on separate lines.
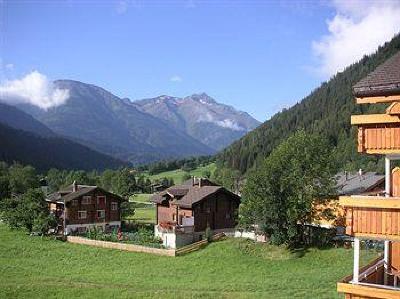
339, 196, 400, 209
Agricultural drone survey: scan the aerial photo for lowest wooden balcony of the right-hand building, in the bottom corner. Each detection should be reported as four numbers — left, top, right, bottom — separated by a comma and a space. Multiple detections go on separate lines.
337, 258, 400, 299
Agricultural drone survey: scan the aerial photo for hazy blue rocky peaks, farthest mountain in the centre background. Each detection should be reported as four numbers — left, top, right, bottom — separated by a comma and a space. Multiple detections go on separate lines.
134, 93, 260, 150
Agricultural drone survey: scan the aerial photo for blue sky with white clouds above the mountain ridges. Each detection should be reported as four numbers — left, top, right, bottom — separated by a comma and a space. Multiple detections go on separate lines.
0, 0, 400, 121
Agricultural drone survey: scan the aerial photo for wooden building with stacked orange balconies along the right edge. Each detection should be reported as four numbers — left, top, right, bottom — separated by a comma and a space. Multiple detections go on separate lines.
337, 52, 400, 299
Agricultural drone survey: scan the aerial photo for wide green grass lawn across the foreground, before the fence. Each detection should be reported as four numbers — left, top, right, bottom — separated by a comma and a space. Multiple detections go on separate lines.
0, 225, 374, 298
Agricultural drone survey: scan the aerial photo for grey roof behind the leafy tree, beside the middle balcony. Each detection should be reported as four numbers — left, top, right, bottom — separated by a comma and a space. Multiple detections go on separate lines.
336, 172, 385, 195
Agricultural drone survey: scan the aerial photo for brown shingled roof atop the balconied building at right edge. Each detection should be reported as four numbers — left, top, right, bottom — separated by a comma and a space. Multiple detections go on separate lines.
353, 51, 400, 97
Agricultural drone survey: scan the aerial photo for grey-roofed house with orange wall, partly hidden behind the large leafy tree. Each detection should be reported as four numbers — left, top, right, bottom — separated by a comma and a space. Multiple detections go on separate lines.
313, 171, 385, 231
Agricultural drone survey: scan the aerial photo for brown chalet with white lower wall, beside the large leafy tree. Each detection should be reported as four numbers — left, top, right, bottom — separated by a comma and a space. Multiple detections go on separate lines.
151, 178, 240, 248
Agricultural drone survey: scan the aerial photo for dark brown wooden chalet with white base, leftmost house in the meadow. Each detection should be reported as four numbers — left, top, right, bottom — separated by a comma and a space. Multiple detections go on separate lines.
46, 182, 124, 234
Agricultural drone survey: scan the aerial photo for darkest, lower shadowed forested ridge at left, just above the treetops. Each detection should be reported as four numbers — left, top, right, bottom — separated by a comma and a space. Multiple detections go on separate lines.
0, 123, 127, 171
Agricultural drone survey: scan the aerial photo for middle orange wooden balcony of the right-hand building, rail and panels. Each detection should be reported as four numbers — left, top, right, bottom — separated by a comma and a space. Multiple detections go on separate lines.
339, 196, 400, 241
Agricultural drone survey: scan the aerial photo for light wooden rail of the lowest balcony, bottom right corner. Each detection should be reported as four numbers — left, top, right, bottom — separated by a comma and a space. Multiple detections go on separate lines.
337, 282, 400, 299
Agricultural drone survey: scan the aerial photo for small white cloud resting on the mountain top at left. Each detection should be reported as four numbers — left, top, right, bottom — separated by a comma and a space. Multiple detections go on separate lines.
0, 71, 69, 109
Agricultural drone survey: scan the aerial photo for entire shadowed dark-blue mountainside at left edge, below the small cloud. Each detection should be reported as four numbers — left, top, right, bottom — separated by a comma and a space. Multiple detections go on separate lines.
0, 103, 128, 171
